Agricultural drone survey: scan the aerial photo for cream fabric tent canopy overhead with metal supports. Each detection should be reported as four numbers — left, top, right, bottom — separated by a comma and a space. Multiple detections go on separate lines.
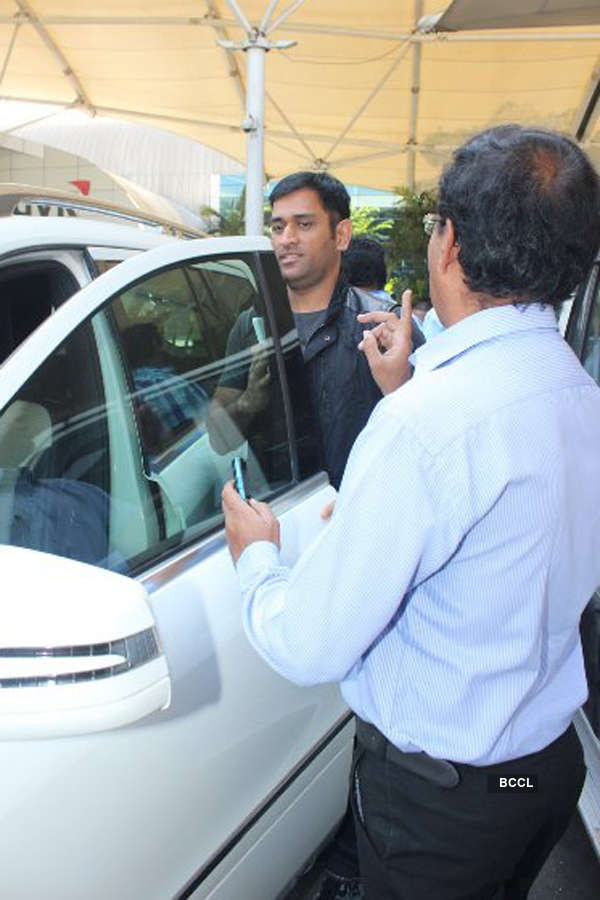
0, 0, 600, 188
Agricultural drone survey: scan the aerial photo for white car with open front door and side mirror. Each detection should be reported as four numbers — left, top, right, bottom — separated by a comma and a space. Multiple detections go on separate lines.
0, 197, 353, 900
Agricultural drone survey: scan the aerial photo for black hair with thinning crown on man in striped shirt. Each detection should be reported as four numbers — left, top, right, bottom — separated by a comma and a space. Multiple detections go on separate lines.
438, 125, 600, 305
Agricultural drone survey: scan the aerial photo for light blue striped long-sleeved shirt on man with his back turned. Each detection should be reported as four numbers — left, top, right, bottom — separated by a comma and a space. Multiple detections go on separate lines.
238, 304, 600, 765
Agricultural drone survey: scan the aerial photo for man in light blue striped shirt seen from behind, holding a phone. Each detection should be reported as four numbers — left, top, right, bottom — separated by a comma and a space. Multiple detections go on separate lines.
223, 125, 600, 900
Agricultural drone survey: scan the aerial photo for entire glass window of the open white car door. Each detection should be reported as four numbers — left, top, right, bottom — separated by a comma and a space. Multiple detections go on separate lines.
0, 250, 292, 571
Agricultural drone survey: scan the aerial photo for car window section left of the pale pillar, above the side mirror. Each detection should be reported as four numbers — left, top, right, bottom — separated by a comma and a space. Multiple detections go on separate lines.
0, 324, 125, 565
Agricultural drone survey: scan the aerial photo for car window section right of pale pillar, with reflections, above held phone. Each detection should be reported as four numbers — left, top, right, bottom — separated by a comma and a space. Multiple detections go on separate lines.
111, 258, 292, 564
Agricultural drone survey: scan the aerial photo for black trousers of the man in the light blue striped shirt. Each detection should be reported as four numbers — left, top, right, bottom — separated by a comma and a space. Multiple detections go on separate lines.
350, 725, 585, 900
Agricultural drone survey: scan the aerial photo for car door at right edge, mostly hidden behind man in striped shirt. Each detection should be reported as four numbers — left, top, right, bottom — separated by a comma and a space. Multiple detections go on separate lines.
567, 261, 600, 855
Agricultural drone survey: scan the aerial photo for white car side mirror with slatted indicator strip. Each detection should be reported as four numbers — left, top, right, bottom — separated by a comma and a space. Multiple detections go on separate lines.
0, 545, 171, 740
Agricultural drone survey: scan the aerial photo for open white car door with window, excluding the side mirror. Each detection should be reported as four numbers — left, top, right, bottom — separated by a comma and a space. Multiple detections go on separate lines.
0, 239, 351, 900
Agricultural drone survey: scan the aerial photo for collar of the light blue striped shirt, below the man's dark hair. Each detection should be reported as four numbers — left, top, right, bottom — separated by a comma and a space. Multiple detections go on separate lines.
410, 303, 558, 372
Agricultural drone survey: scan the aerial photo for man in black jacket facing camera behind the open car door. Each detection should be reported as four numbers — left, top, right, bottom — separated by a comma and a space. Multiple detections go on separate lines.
270, 172, 423, 488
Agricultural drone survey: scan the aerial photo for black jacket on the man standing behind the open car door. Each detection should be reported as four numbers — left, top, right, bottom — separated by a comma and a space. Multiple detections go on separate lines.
304, 275, 424, 488
